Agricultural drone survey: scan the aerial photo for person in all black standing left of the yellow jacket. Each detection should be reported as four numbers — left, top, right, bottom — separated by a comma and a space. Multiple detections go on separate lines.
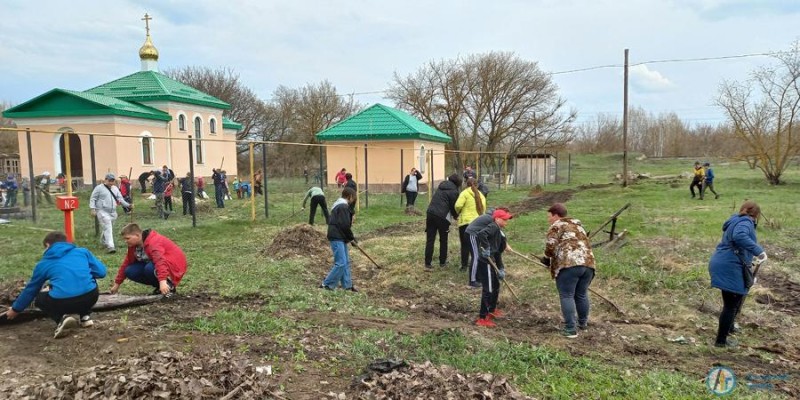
425, 174, 462, 270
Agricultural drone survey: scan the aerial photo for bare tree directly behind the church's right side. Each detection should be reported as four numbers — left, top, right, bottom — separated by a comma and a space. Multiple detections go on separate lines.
164, 66, 267, 141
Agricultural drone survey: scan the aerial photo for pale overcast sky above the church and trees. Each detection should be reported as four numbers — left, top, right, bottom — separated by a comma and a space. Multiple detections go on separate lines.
0, 0, 800, 123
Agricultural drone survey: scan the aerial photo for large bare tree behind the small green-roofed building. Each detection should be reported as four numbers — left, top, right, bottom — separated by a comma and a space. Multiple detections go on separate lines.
387, 52, 576, 168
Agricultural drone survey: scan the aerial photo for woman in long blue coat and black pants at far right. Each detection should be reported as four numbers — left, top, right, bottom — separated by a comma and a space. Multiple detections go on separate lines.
708, 201, 767, 347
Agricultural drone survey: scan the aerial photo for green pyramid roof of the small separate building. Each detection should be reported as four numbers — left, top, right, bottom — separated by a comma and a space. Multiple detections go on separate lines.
317, 104, 452, 143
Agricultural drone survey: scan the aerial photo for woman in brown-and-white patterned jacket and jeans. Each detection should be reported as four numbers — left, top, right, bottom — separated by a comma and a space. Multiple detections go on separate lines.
542, 203, 595, 338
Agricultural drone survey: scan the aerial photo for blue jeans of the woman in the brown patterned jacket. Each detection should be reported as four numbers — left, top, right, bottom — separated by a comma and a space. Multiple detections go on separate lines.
556, 266, 594, 331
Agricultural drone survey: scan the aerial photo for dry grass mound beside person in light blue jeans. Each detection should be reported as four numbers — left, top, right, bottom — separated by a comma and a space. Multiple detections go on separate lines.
261, 224, 331, 261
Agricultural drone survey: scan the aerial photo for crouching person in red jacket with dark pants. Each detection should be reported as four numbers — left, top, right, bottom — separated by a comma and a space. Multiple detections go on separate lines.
111, 224, 186, 297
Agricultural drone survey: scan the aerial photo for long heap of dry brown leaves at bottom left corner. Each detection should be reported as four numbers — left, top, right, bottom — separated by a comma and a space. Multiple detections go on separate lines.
0, 351, 284, 399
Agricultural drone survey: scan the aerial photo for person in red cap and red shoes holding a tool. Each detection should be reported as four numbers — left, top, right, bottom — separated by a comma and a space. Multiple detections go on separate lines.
466, 208, 513, 327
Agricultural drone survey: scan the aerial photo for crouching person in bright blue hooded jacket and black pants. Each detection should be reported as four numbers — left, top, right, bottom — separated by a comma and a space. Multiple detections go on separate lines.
6, 232, 106, 339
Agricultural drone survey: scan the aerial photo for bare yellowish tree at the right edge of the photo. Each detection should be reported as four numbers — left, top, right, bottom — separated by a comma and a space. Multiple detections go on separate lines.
717, 42, 800, 185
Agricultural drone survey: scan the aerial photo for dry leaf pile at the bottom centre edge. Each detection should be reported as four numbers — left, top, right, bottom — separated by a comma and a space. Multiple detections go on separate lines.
356, 360, 532, 400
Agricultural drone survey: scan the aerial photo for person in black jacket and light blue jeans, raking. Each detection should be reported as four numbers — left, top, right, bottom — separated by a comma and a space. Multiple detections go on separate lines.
319, 187, 358, 292
